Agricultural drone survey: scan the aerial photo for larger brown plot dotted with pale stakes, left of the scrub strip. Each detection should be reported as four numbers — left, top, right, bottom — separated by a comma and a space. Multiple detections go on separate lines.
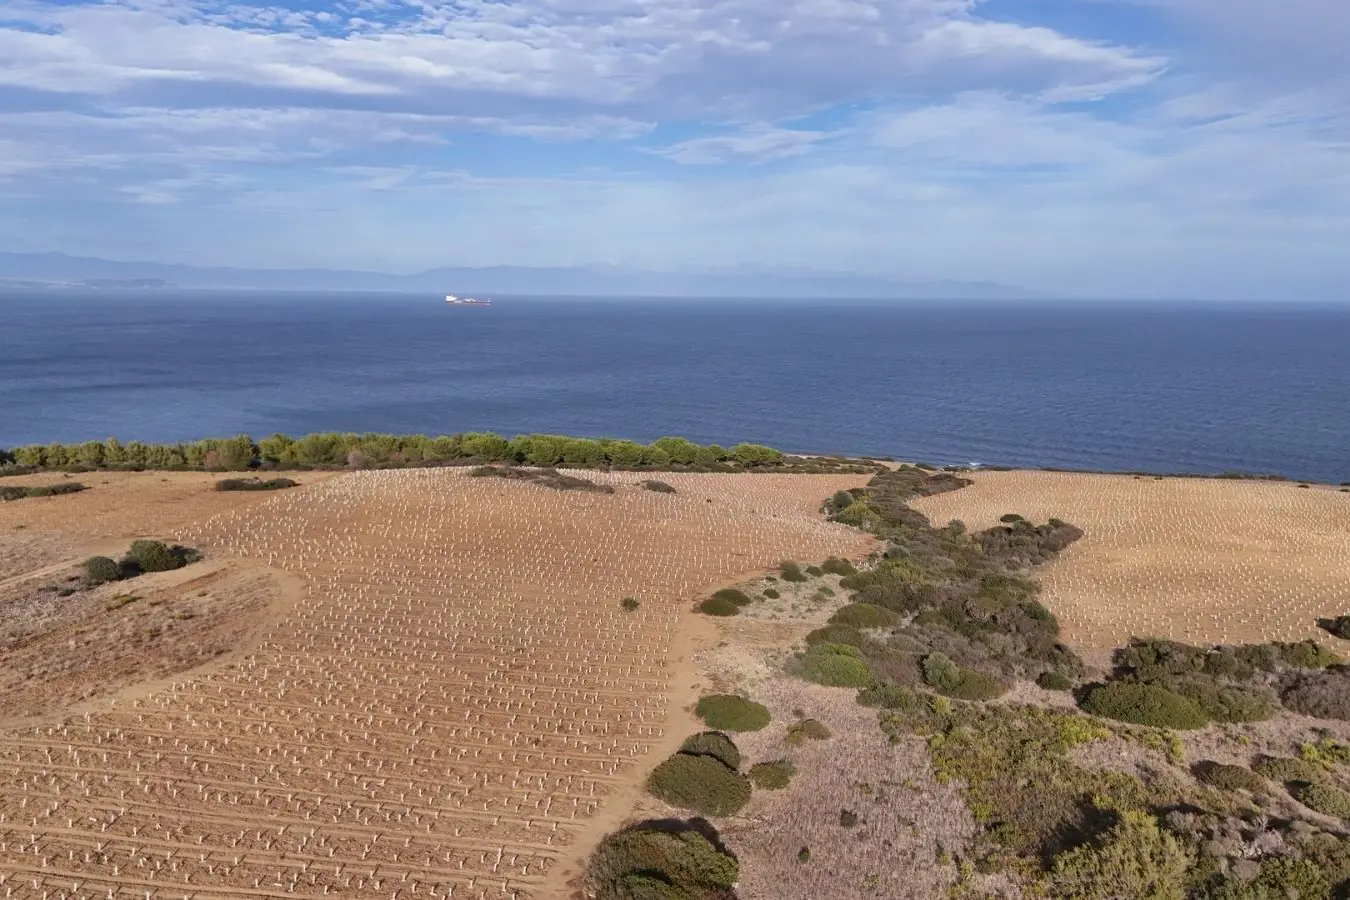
0, 470, 871, 900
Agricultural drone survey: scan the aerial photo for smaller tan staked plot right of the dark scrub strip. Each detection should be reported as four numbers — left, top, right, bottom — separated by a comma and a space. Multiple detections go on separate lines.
913, 472, 1350, 650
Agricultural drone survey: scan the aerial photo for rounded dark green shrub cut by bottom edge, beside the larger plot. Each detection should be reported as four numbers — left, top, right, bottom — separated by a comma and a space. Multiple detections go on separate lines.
585, 822, 740, 900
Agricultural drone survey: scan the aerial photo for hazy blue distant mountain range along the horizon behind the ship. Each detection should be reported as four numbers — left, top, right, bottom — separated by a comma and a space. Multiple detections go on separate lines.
0, 252, 1048, 300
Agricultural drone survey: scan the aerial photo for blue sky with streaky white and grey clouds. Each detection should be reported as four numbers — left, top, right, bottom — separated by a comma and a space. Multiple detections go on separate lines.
0, 0, 1350, 298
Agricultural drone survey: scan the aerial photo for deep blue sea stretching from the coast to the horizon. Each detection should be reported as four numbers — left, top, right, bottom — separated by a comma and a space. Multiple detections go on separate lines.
0, 290, 1350, 482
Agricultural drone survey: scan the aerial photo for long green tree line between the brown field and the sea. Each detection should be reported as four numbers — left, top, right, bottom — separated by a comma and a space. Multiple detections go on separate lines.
0, 432, 784, 471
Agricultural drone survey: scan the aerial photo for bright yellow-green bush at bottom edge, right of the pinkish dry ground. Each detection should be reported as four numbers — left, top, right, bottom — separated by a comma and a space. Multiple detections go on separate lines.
1050, 812, 1192, 900
